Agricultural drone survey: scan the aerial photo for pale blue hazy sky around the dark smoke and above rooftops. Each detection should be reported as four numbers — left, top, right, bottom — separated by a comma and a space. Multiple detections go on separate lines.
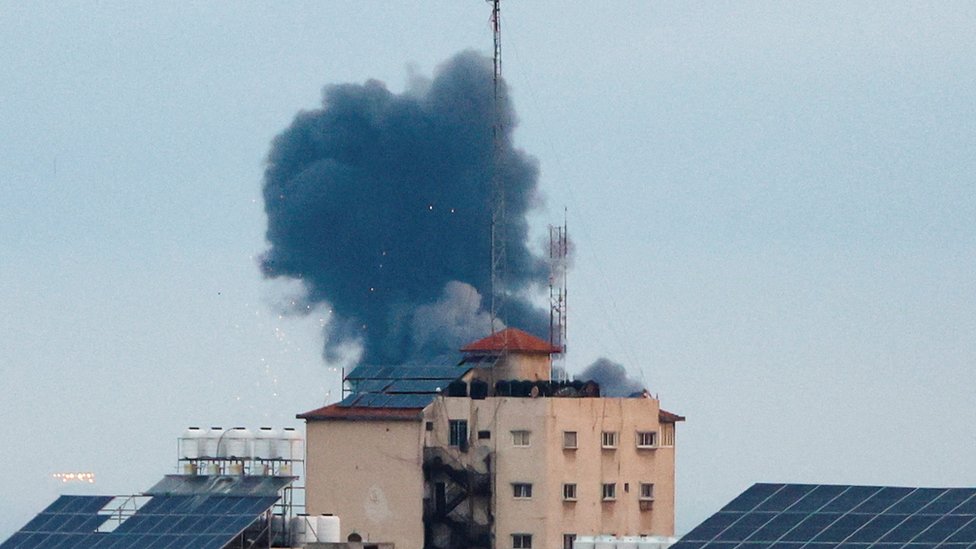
0, 0, 976, 539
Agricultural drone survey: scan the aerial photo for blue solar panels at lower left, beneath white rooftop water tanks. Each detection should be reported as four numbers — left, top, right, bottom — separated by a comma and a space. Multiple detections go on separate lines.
0, 494, 278, 549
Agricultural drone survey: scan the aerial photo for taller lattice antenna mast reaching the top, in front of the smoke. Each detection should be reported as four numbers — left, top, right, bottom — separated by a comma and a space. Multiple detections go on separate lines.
489, 0, 506, 335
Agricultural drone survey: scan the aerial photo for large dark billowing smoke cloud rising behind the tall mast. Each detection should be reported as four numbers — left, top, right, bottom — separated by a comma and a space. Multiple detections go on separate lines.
261, 52, 548, 363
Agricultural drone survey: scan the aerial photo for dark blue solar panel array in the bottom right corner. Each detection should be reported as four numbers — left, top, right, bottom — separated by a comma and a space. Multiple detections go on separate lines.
672, 484, 976, 549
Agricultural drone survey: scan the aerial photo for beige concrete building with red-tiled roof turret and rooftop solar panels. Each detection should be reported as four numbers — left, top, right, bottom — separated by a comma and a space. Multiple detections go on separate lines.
299, 329, 684, 549
